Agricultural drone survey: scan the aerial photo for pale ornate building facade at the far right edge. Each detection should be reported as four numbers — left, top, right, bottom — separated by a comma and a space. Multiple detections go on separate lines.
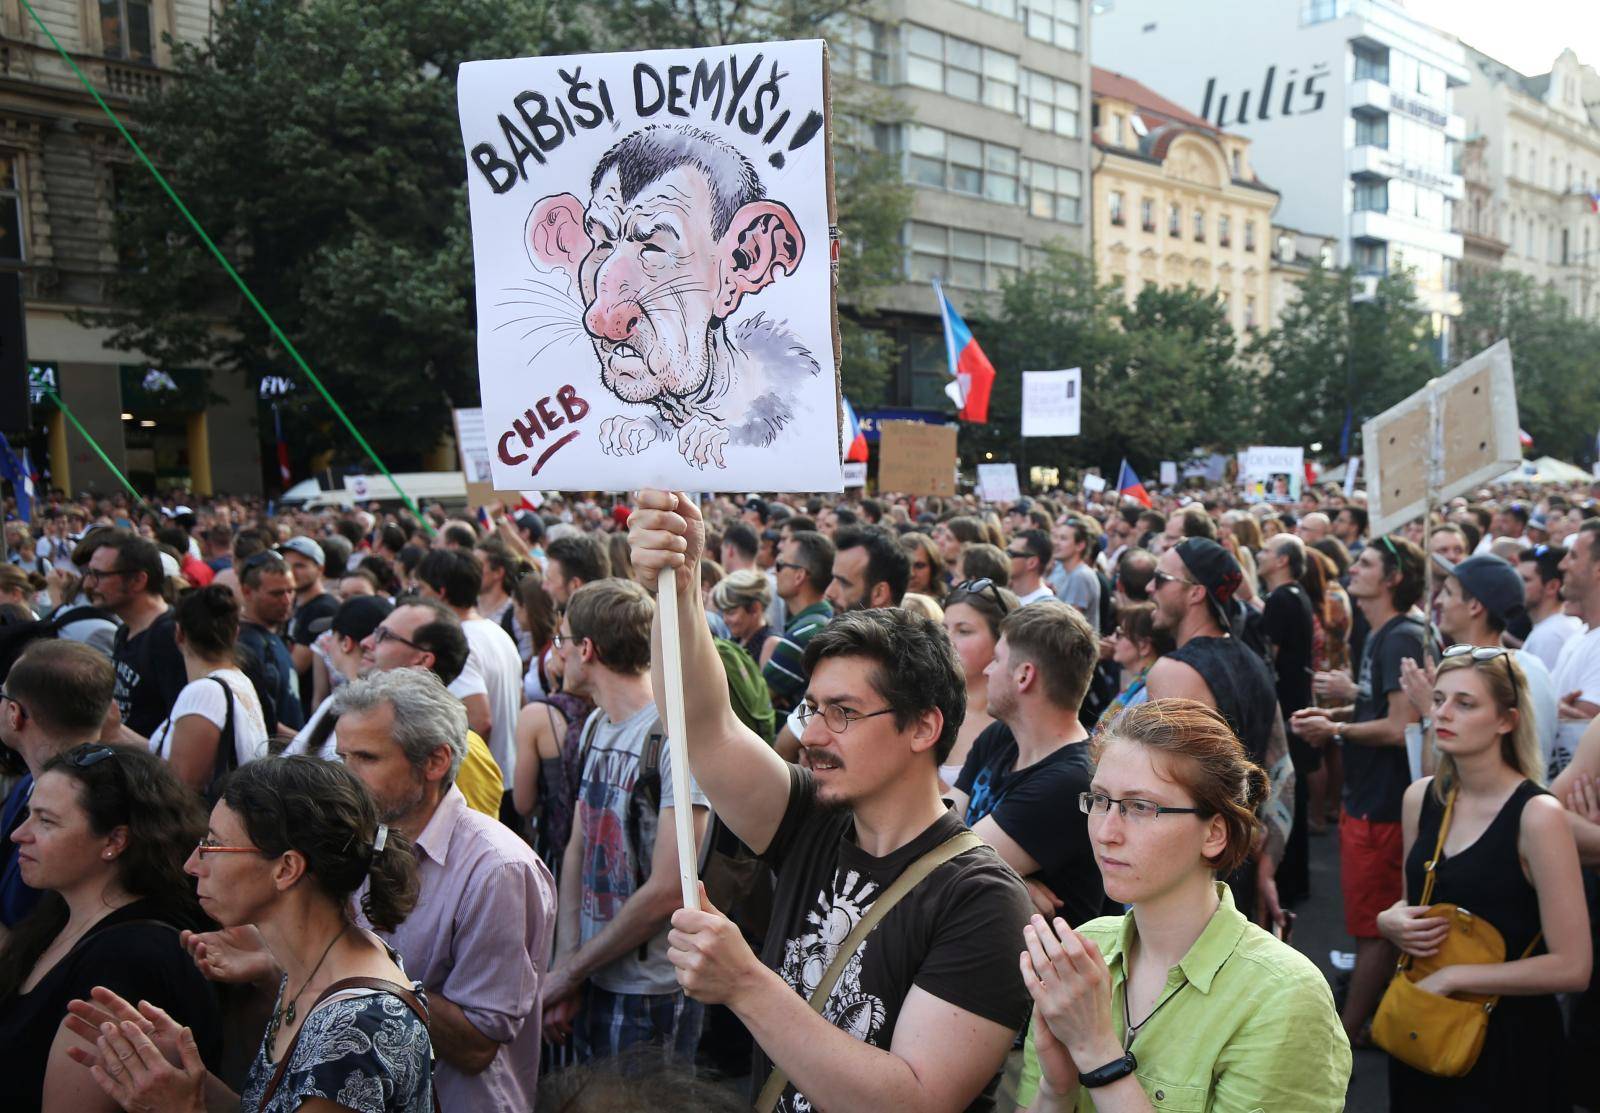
1456, 46, 1600, 318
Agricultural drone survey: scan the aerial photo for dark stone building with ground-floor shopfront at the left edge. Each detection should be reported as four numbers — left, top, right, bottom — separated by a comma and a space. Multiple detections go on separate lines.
0, 0, 262, 493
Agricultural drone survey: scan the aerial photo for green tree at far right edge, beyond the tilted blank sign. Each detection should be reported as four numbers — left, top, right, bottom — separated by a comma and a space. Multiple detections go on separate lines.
1458, 270, 1600, 461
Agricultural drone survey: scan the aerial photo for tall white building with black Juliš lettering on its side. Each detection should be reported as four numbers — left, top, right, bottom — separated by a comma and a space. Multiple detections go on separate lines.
1093, 0, 1469, 356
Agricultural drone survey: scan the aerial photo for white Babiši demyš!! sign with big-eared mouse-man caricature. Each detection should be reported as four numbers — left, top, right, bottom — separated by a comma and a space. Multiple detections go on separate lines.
458, 40, 842, 491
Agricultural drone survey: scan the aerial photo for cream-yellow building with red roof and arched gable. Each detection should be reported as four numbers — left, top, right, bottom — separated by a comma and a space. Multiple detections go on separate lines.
1093, 67, 1278, 336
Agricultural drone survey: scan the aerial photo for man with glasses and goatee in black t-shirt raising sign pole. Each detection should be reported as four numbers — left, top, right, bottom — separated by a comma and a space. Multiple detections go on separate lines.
630, 491, 1030, 1111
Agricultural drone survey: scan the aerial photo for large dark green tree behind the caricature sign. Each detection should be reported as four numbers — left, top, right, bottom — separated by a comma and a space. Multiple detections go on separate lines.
100, 0, 909, 467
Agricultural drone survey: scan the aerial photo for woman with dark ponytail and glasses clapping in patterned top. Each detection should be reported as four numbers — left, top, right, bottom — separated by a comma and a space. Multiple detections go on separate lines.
69, 756, 434, 1113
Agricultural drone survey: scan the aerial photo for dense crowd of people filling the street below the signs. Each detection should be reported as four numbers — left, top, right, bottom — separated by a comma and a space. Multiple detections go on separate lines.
0, 473, 1600, 1113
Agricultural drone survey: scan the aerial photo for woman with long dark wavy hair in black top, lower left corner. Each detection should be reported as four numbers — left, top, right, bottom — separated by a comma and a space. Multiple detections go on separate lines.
0, 745, 219, 1113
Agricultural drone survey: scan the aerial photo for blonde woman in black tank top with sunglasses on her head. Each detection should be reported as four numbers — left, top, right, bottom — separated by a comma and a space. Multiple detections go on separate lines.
1378, 646, 1592, 1111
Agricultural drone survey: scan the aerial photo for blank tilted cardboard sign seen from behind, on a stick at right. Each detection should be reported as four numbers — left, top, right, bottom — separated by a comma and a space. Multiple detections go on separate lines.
1362, 341, 1522, 537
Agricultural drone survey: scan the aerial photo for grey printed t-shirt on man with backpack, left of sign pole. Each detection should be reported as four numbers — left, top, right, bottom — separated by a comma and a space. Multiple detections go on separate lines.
573, 704, 707, 993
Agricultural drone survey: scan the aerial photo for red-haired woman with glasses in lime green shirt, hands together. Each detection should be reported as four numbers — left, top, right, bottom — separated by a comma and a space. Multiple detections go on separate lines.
1019, 699, 1350, 1113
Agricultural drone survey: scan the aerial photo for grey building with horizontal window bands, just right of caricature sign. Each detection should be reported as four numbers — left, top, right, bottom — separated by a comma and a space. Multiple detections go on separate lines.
829, 0, 1091, 409
